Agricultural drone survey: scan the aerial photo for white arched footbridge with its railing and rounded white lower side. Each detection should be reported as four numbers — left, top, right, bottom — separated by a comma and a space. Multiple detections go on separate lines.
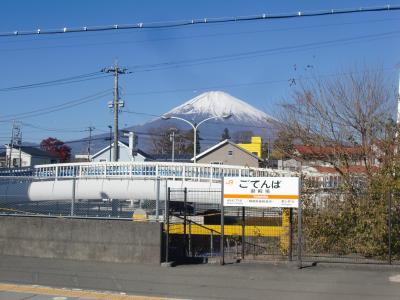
0, 162, 332, 203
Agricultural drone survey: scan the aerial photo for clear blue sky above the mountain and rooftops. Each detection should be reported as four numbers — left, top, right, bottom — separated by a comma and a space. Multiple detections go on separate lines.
0, 0, 400, 143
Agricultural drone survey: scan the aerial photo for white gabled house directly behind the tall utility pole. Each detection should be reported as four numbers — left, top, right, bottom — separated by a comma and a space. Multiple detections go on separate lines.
89, 141, 151, 162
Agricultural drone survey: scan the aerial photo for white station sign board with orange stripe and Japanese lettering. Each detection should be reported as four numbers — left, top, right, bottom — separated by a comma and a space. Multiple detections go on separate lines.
223, 177, 299, 208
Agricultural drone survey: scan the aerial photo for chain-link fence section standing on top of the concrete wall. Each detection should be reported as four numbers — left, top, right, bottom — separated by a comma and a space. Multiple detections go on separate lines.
0, 178, 166, 221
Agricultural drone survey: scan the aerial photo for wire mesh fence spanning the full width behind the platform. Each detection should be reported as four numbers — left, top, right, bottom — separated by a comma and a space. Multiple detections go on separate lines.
0, 178, 400, 263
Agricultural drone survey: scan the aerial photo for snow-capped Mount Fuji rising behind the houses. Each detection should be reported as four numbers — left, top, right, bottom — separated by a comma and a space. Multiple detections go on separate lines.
71, 91, 279, 153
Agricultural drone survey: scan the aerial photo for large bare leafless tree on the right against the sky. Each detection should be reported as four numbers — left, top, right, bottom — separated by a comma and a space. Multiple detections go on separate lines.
281, 68, 396, 190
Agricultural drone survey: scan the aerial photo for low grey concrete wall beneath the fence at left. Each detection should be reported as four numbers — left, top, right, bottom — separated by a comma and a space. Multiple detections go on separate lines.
0, 216, 161, 264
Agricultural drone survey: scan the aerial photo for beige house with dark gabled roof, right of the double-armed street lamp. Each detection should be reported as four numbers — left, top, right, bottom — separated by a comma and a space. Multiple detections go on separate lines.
192, 140, 262, 168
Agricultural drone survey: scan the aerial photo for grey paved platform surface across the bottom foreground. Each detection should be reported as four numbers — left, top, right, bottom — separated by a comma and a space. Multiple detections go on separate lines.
0, 256, 400, 300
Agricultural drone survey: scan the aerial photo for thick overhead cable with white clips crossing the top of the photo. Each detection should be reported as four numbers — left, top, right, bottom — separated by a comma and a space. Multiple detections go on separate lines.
0, 5, 400, 37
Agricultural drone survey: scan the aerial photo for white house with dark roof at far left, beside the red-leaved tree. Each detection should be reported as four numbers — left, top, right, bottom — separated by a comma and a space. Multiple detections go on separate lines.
5, 145, 60, 167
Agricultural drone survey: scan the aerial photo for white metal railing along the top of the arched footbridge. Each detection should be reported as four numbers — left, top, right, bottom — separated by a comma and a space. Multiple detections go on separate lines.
0, 162, 297, 182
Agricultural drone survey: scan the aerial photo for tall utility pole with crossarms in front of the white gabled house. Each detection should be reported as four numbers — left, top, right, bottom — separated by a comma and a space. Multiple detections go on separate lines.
101, 62, 130, 161
